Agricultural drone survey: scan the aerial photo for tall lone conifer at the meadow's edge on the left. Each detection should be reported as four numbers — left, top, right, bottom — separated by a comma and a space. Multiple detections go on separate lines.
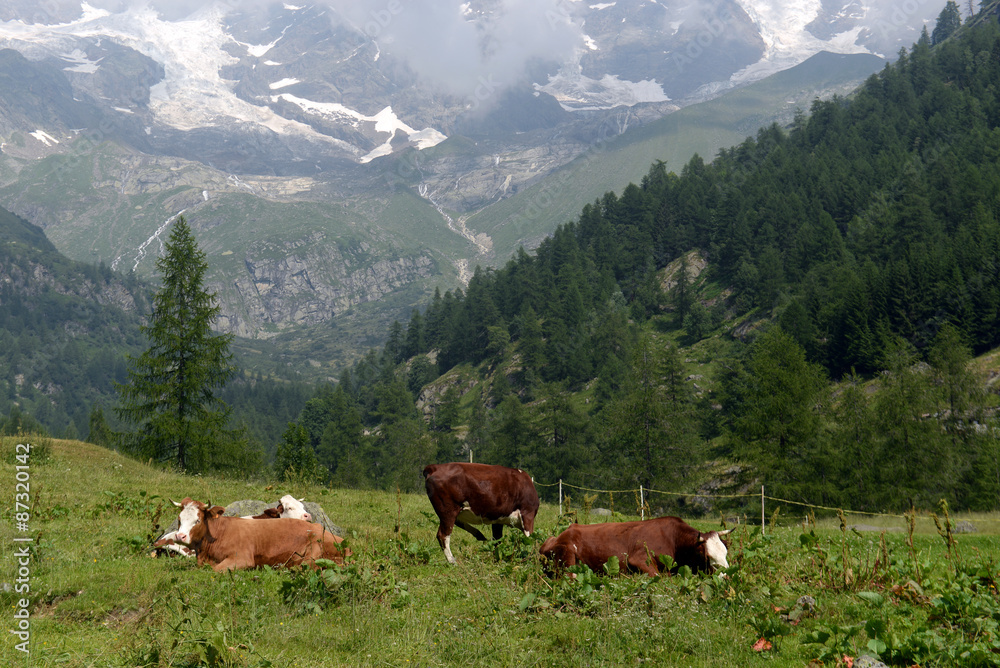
115, 217, 246, 472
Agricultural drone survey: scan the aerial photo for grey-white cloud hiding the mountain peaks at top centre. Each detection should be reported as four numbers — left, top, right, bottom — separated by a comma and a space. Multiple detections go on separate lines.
328, 0, 583, 96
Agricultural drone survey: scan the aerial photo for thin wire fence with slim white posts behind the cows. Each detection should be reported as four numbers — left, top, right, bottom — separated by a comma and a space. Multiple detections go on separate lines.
535, 480, 1000, 526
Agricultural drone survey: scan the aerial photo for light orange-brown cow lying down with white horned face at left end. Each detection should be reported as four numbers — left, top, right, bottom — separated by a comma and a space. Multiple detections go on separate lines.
173, 498, 350, 572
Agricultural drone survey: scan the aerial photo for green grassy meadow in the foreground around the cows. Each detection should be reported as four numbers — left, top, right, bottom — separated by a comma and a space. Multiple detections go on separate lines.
0, 439, 1000, 667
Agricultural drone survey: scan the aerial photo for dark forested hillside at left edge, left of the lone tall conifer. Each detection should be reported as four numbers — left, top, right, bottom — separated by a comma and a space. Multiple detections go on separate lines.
0, 209, 146, 434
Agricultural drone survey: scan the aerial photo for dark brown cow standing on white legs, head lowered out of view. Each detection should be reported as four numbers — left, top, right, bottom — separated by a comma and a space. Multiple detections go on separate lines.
424, 462, 538, 564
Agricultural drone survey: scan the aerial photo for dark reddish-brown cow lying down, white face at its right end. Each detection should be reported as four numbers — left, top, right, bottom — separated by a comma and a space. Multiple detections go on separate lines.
539, 517, 731, 575
